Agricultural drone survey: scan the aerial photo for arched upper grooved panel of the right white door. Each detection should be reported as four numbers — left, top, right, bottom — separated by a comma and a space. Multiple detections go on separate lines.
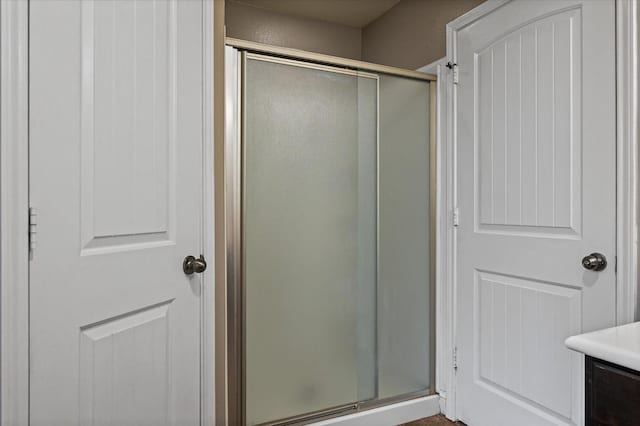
474, 9, 581, 235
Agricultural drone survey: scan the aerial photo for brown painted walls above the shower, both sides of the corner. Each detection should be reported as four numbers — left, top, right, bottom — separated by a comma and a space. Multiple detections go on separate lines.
226, 0, 484, 69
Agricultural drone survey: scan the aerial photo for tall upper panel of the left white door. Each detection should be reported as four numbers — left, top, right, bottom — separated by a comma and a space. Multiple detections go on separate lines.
80, 1, 177, 254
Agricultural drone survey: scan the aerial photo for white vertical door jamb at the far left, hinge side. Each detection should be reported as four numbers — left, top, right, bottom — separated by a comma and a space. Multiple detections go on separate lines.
0, 0, 29, 426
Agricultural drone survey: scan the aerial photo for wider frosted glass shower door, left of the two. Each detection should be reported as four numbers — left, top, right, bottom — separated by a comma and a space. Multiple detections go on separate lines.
242, 54, 378, 425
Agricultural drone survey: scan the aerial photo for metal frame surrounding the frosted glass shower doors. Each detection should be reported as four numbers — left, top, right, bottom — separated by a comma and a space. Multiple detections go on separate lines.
222, 37, 437, 426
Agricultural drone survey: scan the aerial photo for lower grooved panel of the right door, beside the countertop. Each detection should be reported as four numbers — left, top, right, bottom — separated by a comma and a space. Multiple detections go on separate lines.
472, 272, 580, 418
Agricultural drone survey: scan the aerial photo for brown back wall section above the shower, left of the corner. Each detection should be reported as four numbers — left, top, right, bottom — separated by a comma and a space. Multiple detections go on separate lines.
226, 0, 362, 59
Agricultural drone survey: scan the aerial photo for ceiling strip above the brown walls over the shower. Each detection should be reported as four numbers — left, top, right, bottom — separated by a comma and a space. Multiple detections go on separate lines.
232, 0, 400, 28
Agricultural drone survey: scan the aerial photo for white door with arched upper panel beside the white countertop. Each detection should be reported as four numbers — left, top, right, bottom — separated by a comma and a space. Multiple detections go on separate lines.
455, 0, 616, 426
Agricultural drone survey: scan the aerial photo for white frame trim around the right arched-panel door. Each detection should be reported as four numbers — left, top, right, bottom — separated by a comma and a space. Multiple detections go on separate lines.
438, 0, 640, 420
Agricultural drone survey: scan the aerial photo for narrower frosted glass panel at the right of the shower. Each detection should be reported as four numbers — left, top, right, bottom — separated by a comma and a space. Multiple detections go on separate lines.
378, 75, 435, 399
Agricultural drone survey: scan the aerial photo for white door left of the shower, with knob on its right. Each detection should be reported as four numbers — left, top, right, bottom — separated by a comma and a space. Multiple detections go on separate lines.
29, 0, 203, 426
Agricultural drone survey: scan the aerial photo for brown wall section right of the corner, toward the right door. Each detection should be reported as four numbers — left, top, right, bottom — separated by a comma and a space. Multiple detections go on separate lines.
361, 0, 484, 69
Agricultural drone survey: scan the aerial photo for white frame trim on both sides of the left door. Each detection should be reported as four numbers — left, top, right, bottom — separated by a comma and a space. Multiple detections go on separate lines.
0, 0, 220, 426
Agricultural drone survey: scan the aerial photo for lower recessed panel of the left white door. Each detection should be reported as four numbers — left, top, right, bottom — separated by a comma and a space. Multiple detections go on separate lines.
79, 303, 171, 425
